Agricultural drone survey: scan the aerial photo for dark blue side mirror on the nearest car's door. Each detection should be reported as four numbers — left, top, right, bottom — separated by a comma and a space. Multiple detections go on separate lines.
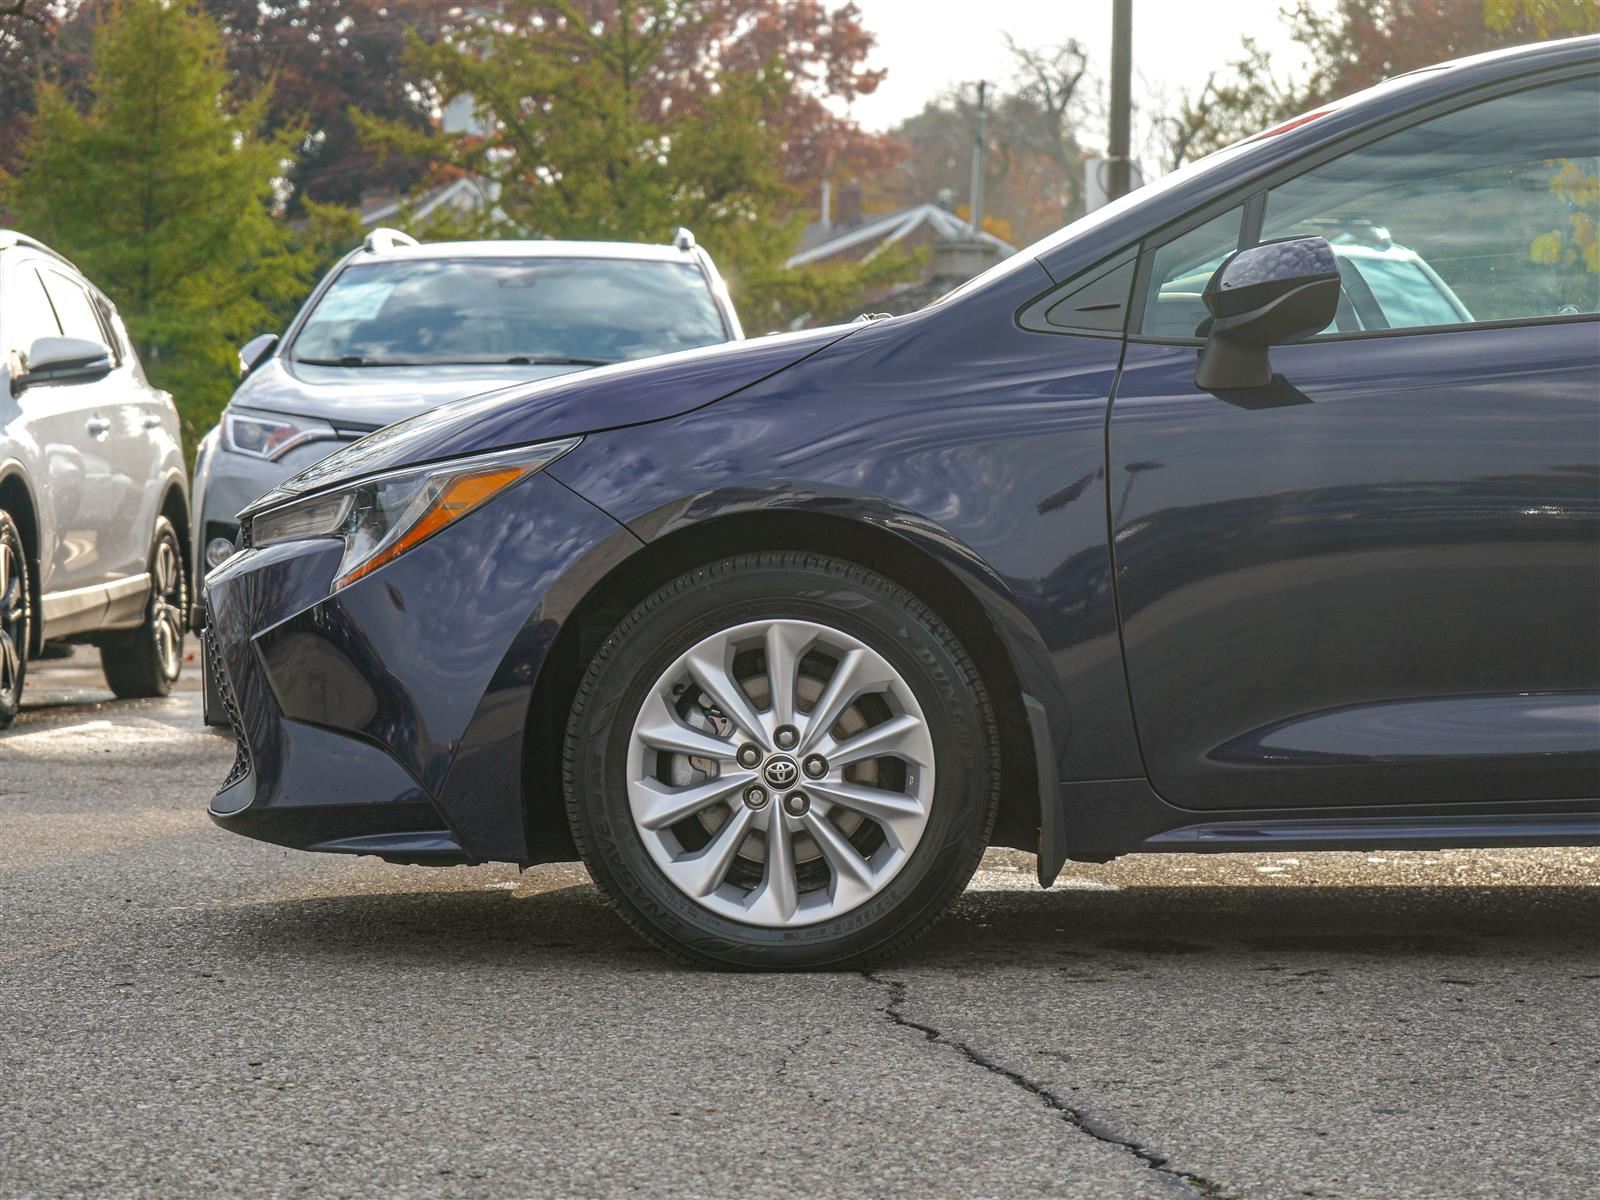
1195, 237, 1339, 392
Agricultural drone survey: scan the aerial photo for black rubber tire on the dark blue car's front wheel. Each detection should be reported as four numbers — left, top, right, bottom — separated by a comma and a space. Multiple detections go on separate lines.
563, 552, 1000, 970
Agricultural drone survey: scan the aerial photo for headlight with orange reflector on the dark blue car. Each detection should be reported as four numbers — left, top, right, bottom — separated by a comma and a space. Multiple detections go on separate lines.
248, 437, 581, 590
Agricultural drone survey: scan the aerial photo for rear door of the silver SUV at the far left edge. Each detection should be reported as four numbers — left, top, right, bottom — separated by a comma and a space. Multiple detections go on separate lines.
40, 264, 134, 582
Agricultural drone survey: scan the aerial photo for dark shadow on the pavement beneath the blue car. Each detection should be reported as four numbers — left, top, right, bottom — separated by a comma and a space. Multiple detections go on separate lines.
211, 883, 1600, 971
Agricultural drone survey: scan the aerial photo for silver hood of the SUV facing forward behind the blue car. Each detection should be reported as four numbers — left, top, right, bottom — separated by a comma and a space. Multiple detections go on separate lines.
222, 357, 579, 429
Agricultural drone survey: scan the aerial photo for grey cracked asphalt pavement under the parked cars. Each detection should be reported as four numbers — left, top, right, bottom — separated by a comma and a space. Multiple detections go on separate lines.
0, 651, 1600, 1200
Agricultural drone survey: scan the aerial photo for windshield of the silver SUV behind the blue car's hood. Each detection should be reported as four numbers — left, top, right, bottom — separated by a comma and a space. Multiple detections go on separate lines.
294, 258, 728, 366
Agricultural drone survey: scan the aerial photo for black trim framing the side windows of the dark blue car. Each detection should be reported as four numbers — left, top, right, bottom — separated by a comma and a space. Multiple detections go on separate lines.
1126, 64, 1600, 346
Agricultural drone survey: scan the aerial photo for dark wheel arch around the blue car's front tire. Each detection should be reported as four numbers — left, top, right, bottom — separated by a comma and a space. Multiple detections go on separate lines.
523, 507, 1054, 861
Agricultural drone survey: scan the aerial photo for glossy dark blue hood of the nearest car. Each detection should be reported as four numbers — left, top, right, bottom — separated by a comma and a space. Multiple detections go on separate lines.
246, 325, 864, 512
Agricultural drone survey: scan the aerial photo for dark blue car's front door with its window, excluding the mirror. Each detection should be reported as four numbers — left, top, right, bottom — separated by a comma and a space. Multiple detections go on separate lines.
1107, 75, 1600, 810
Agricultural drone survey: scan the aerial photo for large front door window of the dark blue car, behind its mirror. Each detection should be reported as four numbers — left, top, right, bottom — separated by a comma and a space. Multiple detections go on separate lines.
1261, 77, 1600, 330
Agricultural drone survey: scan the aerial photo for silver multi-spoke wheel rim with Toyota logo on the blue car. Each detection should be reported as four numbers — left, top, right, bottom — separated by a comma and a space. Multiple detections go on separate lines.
627, 619, 934, 926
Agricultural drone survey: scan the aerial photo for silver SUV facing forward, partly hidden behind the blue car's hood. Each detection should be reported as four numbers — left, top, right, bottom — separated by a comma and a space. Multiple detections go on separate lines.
194, 229, 744, 573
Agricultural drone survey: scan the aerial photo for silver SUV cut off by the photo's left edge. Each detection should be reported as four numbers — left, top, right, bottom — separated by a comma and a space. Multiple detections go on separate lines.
0, 230, 190, 726
